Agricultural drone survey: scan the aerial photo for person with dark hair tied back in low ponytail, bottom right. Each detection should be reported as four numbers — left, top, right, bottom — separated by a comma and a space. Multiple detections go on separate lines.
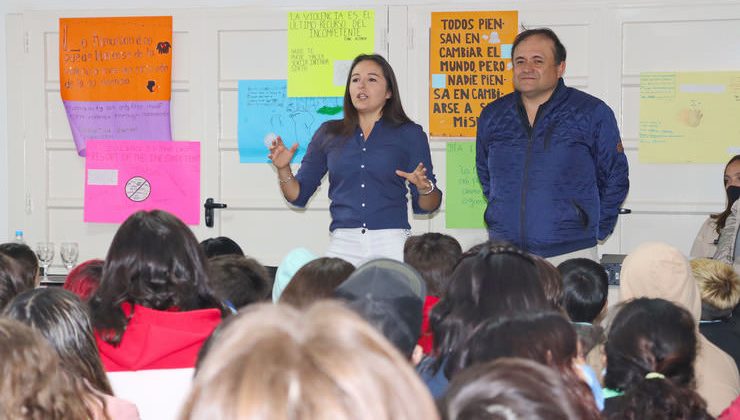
604, 298, 712, 420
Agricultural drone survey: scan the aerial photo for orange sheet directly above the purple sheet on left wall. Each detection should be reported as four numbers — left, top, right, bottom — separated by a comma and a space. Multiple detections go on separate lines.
59, 16, 172, 101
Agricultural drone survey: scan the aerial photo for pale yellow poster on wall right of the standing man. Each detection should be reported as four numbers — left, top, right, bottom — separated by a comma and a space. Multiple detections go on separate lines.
639, 71, 740, 163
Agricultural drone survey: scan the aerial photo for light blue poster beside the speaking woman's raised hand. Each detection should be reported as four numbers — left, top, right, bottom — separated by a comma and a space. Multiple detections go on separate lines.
237, 80, 343, 163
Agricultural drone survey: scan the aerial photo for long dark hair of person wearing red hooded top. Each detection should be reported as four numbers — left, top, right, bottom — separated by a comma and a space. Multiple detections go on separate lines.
90, 210, 223, 345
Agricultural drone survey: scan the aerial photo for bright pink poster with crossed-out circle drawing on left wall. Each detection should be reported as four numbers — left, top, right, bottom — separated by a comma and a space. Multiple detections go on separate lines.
85, 140, 200, 225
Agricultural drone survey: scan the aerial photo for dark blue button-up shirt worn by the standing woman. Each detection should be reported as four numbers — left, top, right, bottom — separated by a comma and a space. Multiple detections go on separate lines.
291, 119, 436, 231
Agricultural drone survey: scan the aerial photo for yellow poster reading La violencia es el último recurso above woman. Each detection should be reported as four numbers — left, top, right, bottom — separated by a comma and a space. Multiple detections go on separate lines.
288, 10, 375, 97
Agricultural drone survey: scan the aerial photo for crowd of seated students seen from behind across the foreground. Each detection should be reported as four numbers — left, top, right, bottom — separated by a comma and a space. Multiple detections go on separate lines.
0, 210, 740, 420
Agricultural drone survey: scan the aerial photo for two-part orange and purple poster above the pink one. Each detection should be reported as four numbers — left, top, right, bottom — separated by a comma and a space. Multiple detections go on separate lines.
59, 16, 173, 156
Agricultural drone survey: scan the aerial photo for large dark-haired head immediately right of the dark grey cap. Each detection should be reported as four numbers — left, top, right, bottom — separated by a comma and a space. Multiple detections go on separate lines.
430, 244, 550, 370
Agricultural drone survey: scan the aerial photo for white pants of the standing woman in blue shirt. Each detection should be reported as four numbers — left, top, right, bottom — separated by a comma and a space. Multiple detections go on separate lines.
326, 228, 411, 267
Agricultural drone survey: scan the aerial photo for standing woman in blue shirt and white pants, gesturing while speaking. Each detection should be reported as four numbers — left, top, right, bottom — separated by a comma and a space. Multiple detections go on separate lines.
268, 54, 442, 266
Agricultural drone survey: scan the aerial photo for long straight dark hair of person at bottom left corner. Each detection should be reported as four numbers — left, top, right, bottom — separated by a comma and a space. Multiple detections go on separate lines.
3, 287, 113, 395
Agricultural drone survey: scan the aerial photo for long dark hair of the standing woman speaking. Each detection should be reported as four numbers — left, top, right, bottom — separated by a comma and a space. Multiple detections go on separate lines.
326, 54, 411, 137
